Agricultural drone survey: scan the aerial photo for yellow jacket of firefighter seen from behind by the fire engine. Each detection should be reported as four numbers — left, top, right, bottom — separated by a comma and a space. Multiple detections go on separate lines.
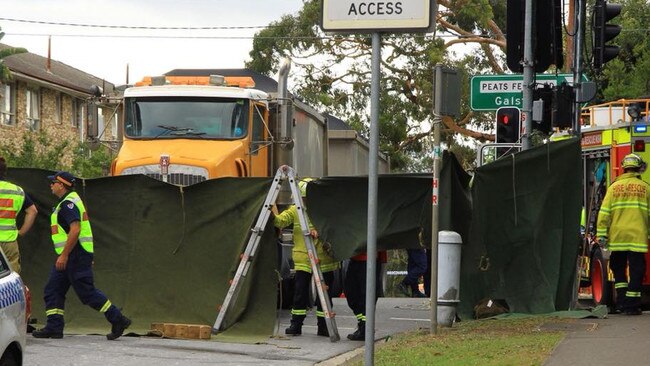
596, 173, 650, 253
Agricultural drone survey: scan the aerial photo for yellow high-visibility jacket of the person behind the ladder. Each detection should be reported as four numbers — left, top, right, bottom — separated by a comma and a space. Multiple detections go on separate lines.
273, 205, 339, 273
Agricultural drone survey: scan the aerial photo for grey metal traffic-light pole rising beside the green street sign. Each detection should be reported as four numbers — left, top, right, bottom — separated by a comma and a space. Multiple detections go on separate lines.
521, 0, 535, 150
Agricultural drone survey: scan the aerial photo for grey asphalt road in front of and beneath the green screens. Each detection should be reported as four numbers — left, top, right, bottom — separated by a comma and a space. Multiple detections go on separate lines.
24, 298, 431, 366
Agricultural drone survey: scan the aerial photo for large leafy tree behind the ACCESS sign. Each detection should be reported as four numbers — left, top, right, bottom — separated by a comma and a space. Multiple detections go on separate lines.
246, 0, 505, 170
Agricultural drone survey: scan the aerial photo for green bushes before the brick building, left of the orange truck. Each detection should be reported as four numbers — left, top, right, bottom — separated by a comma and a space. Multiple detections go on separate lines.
0, 130, 112, 178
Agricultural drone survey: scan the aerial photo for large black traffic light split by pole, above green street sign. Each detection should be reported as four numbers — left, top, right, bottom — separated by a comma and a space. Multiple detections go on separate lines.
506, 0, 564, 73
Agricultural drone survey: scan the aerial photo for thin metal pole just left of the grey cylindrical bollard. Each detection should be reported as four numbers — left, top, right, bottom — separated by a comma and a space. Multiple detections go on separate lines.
429, 64, 442, 334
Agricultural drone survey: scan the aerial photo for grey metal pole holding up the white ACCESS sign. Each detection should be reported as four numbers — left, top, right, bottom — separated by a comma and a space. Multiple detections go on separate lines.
365, 32, 381, 366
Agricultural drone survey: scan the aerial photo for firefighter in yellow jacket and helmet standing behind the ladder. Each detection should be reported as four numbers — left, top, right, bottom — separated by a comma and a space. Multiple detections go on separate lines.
274, 178, 339, 337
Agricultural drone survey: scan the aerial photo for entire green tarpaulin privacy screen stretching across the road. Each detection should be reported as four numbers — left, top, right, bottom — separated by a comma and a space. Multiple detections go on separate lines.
8, 141, 581, 341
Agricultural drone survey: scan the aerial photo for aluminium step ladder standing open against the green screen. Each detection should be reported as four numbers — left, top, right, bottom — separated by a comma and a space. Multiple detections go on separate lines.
212, 165, 341, 342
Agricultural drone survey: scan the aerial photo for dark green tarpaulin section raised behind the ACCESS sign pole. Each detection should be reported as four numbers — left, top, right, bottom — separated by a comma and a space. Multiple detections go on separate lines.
307, 154, 471, 260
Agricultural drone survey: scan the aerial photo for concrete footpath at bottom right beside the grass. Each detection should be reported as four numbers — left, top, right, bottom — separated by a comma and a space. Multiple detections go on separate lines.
544, 312, 650, 366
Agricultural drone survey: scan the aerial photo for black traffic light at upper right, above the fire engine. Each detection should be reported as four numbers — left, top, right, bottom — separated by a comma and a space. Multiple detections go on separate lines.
592, 0, 623, 70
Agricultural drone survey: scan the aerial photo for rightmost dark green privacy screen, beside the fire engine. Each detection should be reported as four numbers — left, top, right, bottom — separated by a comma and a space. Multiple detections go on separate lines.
460, 139, 582, 317
